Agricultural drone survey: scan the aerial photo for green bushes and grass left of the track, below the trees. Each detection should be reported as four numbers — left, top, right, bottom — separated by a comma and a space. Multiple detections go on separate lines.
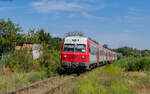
0, 47, 60, 94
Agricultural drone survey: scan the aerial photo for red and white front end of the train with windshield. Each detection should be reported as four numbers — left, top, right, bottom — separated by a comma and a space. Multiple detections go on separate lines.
61, 36, 89, 68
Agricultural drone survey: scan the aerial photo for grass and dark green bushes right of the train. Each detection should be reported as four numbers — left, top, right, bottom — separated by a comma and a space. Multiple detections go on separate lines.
75, 57, 150, 94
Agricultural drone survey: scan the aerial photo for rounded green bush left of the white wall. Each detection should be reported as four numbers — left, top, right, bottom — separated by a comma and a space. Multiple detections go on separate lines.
5, 49, 33, 72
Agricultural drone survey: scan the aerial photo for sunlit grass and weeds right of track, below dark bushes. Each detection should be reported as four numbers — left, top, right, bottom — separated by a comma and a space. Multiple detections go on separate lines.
43, 63, 150, 94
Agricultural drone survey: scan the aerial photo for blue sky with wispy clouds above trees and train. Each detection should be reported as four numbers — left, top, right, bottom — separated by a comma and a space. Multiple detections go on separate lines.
0, 0, 150, 49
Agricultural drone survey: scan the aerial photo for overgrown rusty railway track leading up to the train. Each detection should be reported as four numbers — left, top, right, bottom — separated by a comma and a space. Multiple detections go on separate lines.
6, 76, 72, 94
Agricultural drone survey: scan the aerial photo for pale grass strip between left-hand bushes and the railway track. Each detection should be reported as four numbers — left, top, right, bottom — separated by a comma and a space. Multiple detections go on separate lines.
0, 72, 46, 94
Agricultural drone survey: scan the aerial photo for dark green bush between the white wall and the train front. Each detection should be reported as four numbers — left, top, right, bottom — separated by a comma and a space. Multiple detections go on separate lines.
39, 47, 60, 77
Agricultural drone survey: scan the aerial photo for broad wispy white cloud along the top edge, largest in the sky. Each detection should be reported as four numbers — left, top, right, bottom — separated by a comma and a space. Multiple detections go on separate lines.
30, 0, 105, 13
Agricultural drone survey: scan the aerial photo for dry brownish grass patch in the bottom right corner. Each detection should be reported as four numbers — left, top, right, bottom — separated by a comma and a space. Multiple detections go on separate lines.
125, 72, 150, 94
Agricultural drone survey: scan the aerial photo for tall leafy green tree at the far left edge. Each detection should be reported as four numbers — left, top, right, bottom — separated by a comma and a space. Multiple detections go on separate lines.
0, 19, 22, 53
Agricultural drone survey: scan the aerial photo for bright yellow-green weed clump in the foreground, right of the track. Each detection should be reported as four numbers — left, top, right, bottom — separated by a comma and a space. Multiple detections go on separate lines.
76, 66, 132, 94
